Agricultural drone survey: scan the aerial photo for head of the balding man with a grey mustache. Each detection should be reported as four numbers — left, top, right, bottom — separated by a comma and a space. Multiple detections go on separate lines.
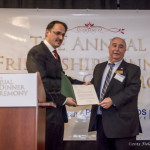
109, 37, 126, 62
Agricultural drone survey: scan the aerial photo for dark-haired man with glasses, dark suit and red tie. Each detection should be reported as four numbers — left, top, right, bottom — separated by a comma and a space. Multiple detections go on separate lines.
27, 21, 82, 150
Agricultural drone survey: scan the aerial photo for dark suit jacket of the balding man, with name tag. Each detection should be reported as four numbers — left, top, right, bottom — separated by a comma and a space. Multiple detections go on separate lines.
89, 61, 141, 138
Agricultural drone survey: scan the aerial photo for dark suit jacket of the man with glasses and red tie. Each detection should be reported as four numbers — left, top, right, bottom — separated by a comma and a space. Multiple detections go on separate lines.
27, 42, 82, 122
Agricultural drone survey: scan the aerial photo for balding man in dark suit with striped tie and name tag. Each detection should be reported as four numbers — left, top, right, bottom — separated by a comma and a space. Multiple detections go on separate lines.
89, 37, 141, 150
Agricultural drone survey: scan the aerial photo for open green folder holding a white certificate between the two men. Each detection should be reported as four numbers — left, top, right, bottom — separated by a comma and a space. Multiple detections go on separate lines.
61, 73, 99, 105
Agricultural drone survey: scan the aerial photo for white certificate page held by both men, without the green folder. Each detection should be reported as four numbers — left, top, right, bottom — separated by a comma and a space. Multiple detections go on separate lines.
72, 84, 99, 105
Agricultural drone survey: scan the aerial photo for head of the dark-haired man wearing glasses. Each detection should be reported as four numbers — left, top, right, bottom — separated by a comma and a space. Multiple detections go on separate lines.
45, 20, 68, 49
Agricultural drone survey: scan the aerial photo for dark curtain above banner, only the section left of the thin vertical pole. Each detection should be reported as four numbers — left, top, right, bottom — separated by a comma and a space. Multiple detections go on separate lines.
0, 0, 117, 9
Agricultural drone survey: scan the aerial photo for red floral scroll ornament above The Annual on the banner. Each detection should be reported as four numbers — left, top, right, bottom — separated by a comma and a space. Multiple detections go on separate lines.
68, 22, 125, 34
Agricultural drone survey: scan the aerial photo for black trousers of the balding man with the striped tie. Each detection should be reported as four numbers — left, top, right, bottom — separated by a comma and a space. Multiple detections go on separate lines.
97, 115, 136, 150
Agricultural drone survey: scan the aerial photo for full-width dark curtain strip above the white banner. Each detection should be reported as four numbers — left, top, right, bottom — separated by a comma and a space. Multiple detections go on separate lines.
0, 0, 150, 9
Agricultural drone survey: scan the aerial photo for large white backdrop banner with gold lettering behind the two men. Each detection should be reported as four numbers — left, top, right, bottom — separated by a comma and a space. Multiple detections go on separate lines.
0, 9, 150, 141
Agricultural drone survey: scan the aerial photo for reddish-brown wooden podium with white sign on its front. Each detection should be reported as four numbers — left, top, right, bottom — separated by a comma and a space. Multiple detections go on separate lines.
0, 73, 46, 150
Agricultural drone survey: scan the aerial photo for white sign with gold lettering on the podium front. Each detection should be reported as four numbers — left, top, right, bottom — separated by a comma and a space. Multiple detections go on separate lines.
0, 73, 37, 107
